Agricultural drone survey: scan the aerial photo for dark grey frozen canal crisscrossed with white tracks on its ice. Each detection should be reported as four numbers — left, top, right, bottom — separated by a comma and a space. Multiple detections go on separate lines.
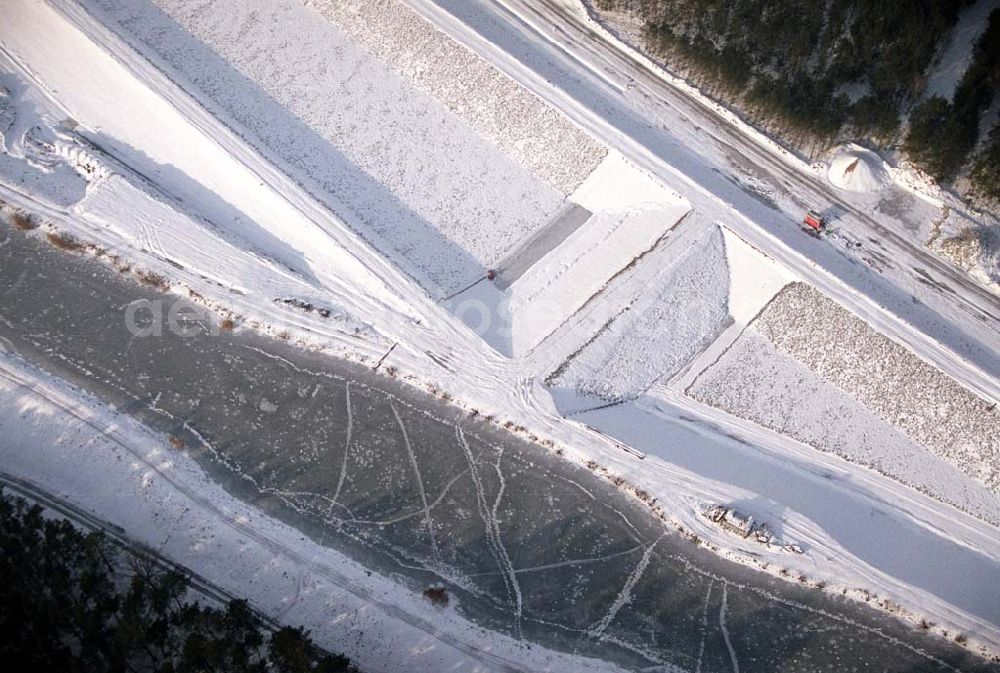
0, 224, 997, 673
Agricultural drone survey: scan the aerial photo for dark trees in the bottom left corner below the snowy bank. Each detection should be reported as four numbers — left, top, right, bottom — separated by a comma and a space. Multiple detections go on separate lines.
0, 490, 355, 673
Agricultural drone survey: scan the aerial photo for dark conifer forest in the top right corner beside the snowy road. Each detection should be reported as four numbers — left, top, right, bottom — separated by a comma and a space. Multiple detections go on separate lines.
595, 0, 1000, 198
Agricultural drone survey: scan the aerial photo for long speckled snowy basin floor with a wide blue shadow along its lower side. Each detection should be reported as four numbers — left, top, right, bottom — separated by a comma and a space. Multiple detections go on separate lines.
89, 0, 586, 297
